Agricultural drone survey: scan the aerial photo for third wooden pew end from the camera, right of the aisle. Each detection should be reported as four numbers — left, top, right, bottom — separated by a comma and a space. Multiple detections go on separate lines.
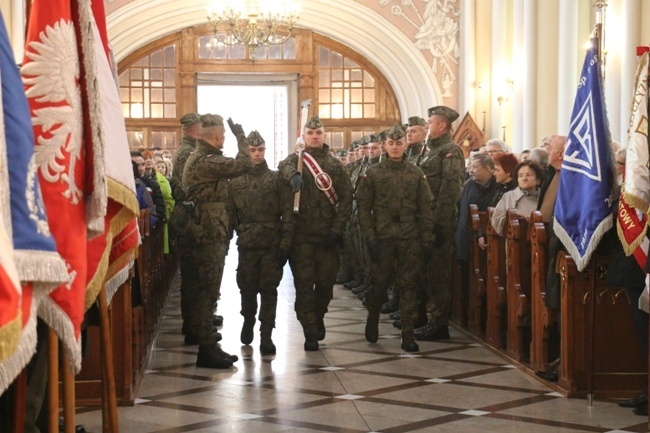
505, 209, 531, 362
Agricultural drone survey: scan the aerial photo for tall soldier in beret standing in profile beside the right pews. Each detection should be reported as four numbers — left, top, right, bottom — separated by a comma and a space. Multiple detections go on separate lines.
415, 106, 465, 341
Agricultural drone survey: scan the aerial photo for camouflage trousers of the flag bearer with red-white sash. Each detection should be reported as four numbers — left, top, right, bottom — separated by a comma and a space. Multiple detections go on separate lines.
289, 237, 339, 334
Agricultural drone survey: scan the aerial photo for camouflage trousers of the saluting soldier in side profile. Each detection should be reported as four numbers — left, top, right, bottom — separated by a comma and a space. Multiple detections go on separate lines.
181, 241, 228, 344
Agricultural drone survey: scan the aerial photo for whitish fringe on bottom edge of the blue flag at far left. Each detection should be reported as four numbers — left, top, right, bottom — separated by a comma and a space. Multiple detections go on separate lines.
14, 250, 70, 288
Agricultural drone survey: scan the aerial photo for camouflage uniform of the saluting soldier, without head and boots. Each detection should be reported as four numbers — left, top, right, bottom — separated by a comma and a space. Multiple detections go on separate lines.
183, 130, 253, 345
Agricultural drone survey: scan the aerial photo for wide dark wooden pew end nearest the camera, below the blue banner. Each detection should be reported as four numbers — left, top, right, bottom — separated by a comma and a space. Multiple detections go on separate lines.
557, 251, 648, 397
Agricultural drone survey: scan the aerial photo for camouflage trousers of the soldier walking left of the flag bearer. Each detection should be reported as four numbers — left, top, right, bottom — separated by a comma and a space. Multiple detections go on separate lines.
237, 248, 283, 329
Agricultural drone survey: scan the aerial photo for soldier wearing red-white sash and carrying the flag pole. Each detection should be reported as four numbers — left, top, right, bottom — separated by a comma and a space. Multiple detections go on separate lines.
279, 116, 352, 351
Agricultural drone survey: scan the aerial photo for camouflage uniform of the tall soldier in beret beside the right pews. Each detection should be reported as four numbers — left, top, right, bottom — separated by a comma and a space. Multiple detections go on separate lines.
420, 133, 465, 326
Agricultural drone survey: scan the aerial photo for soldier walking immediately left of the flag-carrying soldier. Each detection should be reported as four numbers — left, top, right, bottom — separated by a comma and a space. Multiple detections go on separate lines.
227, 131, 292, 355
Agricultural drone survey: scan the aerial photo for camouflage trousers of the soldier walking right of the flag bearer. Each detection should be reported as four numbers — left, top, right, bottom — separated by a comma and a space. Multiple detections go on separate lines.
366, 238, 421, 332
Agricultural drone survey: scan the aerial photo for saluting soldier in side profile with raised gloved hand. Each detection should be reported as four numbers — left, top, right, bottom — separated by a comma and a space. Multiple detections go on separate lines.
183, 114, 253, 368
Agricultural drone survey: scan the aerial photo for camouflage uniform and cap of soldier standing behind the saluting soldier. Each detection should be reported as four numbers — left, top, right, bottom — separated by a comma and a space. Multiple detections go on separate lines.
169, 113, 200, 334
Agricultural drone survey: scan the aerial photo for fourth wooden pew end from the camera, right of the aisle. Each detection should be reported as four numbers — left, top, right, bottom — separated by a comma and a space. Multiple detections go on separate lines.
485, 208, 507, 349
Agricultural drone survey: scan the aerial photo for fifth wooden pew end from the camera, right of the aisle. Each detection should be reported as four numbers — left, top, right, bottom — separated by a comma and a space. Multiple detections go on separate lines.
467, 204, 488, 337
